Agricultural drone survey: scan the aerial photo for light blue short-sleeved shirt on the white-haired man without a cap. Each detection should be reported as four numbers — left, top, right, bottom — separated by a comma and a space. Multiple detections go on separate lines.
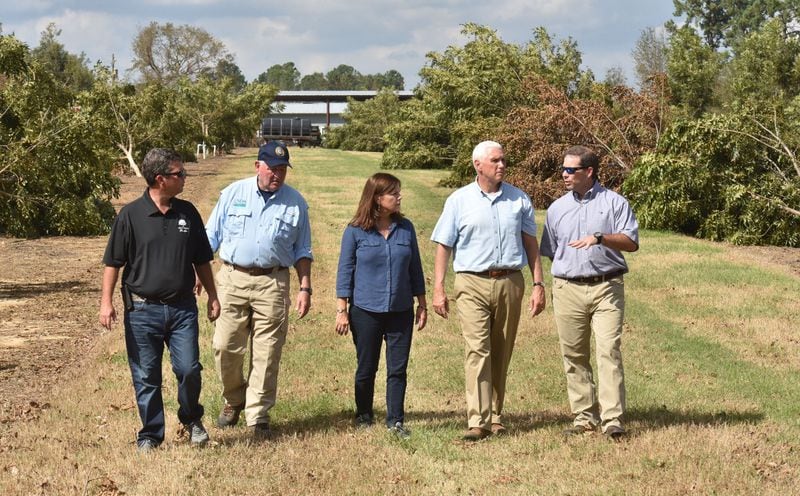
431, 180, 536, 272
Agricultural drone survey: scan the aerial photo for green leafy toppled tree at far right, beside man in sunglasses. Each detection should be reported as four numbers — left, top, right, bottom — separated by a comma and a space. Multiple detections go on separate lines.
623, 110, 800, 246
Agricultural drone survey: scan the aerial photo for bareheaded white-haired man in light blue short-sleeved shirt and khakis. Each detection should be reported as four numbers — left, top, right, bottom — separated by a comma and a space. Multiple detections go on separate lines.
431, 141, 545, 441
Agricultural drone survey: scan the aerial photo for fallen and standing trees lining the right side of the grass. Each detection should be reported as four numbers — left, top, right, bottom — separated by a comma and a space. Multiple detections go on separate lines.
328, 0, 800, 246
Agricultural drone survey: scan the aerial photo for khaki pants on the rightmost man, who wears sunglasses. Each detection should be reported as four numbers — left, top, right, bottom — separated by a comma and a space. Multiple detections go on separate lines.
553, 276, 625, 431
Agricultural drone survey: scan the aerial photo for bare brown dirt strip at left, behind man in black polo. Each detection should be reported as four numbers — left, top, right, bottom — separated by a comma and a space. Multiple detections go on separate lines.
0, 150, 246, 422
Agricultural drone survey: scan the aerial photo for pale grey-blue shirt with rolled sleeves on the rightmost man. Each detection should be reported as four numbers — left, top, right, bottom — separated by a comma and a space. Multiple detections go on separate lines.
540, 182, 639, 279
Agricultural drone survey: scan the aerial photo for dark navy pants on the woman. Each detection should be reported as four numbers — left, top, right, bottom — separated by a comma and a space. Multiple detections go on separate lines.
350, 305, 414, 427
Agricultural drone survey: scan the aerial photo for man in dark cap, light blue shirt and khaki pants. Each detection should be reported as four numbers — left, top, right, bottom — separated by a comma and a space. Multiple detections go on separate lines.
206, 141, 313, 440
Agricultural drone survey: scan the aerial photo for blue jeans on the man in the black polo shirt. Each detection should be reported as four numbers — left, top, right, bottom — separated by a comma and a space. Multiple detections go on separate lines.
125, 298, 203, 444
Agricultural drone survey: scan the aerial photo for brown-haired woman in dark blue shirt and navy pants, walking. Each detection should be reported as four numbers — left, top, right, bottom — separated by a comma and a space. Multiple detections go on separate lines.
336, 172, 428, 438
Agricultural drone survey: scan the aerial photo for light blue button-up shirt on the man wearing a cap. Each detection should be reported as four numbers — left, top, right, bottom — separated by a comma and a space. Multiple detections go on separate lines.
206, 177, 313, 268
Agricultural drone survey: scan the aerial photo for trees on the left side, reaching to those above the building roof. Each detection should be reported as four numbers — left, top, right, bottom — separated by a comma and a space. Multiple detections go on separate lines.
0, 22, 403, 237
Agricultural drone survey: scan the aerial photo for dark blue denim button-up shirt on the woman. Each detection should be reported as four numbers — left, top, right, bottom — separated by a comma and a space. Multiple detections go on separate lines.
336, 219, 425, 312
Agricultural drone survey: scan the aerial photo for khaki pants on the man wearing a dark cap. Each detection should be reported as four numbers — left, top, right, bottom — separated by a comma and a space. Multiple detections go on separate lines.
213, 265, 290, 426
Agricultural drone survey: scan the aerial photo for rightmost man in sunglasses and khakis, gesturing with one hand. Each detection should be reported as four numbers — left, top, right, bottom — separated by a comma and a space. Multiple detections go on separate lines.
542, 146, 639, 440
